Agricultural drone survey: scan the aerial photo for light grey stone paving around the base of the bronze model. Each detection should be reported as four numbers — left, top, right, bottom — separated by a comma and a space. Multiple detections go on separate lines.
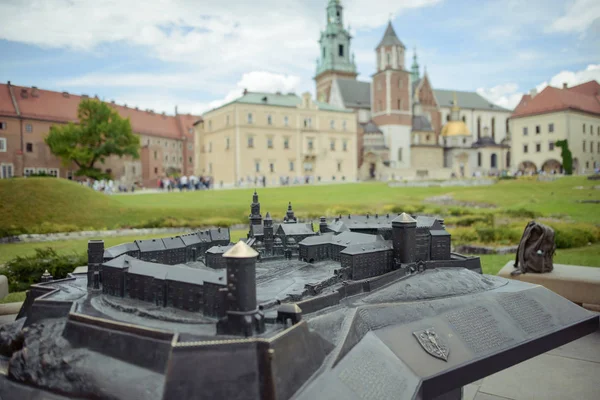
0, 314, 600, 400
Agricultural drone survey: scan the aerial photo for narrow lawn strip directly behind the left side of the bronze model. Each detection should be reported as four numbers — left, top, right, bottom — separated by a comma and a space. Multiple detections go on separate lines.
0, 230, 248, 264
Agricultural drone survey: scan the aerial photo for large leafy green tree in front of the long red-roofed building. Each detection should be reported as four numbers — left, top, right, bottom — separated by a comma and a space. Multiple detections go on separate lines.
45, 99, 140, 179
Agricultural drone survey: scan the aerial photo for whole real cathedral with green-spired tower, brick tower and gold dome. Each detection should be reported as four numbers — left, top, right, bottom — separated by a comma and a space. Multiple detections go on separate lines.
315, 0, 511, 180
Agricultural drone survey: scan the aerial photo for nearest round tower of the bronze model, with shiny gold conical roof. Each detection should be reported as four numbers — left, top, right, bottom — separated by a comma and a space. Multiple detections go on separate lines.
217, 241, 265, 336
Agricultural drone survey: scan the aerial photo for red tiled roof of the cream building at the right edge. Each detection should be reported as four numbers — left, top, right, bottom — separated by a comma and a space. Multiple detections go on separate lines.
511, 81, 600, 118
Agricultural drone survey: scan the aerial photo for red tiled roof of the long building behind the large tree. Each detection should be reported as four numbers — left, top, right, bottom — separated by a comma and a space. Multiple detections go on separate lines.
0, 84, 199, 139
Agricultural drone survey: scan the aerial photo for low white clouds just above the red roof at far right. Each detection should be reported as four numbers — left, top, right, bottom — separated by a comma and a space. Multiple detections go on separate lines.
477, 64, 600, 109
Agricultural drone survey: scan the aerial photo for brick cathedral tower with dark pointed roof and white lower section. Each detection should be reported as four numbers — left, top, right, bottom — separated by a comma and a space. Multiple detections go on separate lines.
371, 21, 412, 168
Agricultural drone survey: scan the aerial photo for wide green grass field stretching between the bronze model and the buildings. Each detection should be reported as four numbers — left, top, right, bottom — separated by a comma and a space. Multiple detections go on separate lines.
0, 177, 600, 236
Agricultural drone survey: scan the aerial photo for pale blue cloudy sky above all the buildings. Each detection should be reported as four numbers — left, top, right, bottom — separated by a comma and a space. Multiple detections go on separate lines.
0, 0, 600, 114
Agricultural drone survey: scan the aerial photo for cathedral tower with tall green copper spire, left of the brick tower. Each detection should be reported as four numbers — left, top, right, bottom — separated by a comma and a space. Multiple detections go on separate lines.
314, 0, 357, 102
